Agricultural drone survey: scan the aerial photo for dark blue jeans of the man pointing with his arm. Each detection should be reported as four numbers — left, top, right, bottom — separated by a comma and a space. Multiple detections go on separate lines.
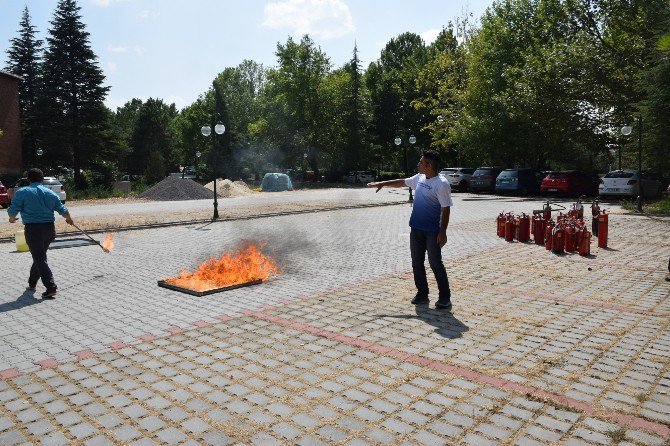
409, 228, 451, 301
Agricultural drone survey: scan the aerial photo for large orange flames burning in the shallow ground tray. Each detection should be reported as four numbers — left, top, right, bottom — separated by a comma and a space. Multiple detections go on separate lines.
165, 242, 279, 291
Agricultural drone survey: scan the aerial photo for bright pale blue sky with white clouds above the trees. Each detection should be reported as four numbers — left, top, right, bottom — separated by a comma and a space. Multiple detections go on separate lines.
0, 0, 493, 110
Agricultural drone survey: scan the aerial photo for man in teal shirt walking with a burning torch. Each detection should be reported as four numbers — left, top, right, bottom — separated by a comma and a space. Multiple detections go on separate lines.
7, 169, 74, 299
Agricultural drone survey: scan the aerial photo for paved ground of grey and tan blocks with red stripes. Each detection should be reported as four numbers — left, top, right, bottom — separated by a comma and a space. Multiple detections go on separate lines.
0, 194, 670, 445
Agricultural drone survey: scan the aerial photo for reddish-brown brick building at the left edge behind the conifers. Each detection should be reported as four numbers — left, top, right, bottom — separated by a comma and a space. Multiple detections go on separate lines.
0, 71, 23, 175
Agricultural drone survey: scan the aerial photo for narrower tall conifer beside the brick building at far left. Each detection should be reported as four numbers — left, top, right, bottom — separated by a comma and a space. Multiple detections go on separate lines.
5, 6, 42, 171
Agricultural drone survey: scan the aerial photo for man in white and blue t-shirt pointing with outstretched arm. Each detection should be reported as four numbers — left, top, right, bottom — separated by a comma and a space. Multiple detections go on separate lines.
368, 150, 453, 310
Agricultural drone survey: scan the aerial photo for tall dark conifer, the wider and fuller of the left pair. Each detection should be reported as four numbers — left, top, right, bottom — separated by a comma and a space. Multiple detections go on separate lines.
40, 0, 110, 188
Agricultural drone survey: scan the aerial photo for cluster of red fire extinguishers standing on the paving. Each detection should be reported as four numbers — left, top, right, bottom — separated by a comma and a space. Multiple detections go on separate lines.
497, 197, 608, 256
